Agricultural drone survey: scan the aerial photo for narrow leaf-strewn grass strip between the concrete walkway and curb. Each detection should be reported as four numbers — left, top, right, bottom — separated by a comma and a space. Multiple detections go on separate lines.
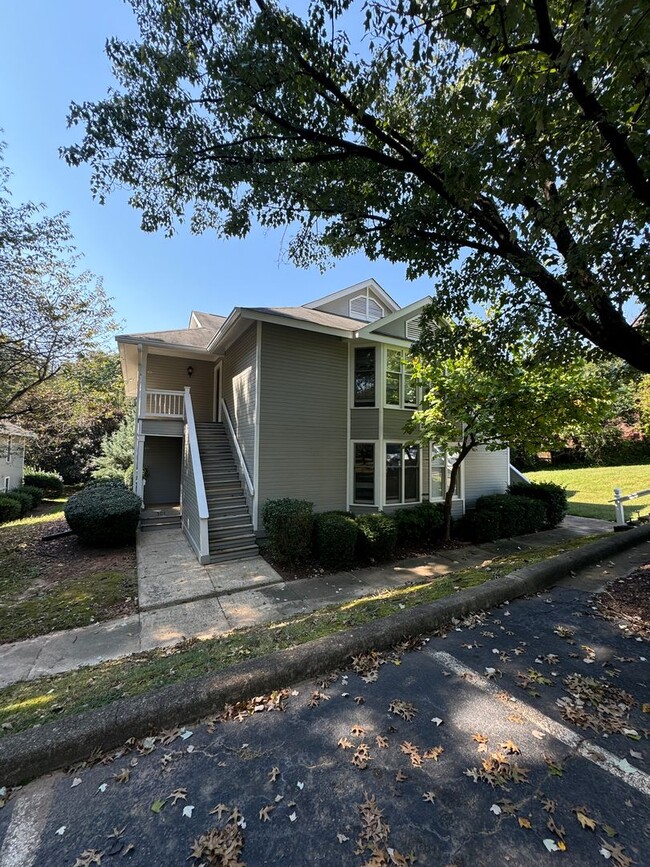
0, 536, 600, 736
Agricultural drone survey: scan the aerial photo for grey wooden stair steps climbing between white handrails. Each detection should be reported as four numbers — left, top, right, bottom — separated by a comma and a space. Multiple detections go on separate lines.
196, 422, 259, 563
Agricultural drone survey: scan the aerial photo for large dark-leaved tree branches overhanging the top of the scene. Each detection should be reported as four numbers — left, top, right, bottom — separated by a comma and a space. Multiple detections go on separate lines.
65, 0, 650, 372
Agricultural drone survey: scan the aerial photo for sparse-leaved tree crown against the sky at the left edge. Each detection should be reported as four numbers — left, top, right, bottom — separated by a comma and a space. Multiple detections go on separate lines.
0, 145, 115, 418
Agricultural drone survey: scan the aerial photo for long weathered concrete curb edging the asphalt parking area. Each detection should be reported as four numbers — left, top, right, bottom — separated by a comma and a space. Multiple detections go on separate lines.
0, 525, 650, 786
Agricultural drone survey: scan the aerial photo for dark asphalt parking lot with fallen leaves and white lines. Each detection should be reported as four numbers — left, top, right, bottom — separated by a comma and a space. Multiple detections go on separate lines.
0, 544, 650, 867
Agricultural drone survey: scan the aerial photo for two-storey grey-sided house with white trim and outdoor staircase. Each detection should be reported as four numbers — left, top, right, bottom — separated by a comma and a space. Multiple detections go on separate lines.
117, 280, 509, 562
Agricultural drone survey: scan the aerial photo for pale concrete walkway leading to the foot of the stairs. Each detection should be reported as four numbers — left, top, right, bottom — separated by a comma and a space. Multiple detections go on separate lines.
0, 516, 612, 688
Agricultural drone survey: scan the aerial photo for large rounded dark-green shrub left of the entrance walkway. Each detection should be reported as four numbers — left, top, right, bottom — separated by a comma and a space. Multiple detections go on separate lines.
63, 485, 142, 548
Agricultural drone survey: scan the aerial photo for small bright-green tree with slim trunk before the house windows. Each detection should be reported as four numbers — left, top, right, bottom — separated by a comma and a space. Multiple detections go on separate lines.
407, 317, 617, 539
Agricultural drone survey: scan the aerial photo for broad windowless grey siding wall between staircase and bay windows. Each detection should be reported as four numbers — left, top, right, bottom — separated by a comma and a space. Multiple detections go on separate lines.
259, 323, 348, 524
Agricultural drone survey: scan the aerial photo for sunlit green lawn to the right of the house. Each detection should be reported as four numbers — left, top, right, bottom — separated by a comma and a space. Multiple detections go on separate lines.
525, 464, 650, 521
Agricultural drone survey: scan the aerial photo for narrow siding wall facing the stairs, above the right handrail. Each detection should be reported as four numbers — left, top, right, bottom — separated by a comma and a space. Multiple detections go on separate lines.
223, 325, 257, 478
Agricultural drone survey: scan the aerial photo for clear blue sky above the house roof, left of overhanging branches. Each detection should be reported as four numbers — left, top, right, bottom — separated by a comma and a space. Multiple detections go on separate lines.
0, 0, 433, 331
